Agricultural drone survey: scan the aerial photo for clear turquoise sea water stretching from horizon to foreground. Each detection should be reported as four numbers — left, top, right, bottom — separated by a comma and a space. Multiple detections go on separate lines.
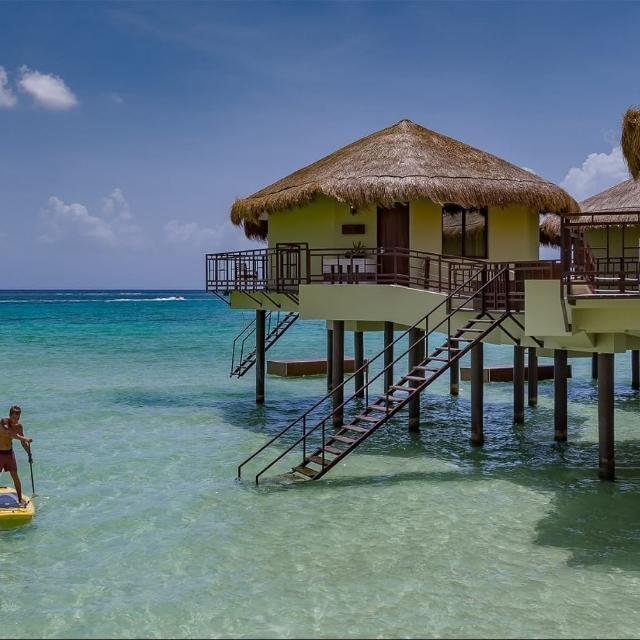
0, 291, 640, 638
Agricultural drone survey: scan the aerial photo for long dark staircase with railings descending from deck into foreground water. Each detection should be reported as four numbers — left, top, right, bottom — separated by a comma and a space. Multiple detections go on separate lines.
238, 266, 522, 484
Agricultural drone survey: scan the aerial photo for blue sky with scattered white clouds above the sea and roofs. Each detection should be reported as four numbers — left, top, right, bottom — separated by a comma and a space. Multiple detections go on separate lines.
0, 2, 640, 288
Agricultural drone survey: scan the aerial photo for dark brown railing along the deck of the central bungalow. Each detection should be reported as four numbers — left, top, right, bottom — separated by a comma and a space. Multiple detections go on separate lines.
206, 243, 561, 309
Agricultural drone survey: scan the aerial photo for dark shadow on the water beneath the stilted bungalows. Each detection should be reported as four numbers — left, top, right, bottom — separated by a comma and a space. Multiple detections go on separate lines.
228, 394, 640, 572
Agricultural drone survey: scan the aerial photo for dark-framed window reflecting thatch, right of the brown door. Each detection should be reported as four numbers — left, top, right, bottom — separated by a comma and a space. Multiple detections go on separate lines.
442, 204, 487, 258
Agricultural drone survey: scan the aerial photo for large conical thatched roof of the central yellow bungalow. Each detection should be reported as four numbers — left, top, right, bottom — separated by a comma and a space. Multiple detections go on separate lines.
231, 120, 578, 238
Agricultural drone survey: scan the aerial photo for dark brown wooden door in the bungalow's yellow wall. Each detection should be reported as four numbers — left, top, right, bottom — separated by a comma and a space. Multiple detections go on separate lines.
378, 204, 409, 282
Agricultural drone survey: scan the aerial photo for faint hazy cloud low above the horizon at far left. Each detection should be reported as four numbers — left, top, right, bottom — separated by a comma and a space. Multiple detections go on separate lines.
39, 189, 141, 247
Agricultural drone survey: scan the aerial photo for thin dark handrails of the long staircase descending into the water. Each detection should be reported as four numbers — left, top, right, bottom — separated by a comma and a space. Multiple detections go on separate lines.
238, 265, 509, 482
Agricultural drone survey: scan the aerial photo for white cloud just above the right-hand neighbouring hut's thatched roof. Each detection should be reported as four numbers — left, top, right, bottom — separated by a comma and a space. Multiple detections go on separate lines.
561, 146, 629, 200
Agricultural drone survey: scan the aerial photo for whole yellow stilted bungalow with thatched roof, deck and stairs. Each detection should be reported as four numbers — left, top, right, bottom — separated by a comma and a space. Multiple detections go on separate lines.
206, 120, 640, 482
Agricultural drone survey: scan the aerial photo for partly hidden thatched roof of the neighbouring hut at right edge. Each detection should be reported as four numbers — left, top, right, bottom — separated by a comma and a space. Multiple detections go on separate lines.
540, 178, 640, 246
